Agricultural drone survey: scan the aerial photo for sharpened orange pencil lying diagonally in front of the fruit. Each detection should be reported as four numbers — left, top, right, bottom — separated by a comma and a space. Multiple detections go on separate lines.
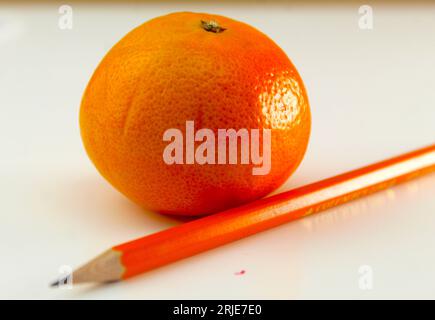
52, 144, 435, 286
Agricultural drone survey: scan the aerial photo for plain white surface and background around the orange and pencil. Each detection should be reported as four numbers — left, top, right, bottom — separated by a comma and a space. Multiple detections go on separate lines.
0, 2, 435, 299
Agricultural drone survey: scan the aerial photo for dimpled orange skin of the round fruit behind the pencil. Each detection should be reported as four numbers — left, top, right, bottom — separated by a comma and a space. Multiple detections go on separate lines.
80, 12, 311, 215
